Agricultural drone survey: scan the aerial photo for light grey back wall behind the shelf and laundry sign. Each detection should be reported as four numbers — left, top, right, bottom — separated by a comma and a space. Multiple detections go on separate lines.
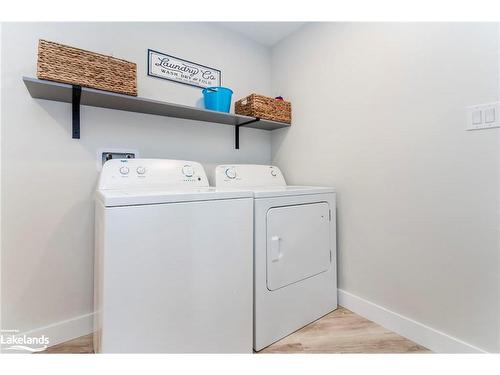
1, 23, 271, 340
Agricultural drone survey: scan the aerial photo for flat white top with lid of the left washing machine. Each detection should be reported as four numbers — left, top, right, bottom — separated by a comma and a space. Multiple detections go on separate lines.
96, 188, 253, 207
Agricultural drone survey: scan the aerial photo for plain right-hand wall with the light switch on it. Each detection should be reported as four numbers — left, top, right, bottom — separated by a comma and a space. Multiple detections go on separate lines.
271, 23, 500, 351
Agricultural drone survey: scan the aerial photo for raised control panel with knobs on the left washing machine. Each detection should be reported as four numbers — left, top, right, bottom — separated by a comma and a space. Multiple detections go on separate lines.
98, 159, 208, 190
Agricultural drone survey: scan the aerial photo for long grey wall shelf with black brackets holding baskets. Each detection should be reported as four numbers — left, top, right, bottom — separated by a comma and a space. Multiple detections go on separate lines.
23, 77, 290, 148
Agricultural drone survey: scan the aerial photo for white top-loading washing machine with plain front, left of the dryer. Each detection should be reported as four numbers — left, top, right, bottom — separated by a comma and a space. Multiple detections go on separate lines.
94, 159, 253, 353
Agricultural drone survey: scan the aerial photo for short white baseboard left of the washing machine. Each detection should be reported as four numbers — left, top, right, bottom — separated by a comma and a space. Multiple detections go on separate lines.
17, 313, 94, 347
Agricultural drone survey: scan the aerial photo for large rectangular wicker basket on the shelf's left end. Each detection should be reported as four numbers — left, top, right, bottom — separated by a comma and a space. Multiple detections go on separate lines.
37, 39, 137, 96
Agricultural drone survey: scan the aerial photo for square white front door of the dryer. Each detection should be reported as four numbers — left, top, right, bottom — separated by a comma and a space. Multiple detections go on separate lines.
267, 202, 331, 290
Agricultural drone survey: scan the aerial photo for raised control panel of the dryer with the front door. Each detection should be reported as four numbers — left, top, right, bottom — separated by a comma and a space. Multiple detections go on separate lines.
215, 164, 286, 188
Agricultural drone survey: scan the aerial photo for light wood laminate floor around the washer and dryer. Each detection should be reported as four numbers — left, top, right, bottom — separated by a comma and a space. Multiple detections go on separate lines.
39, 307, 430, 353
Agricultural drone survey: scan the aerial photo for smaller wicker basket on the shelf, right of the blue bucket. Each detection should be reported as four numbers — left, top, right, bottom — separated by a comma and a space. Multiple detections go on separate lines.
234, 94, 292, 124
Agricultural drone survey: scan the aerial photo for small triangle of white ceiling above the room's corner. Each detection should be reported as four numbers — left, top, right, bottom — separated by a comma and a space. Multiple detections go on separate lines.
217, 22, 305, 47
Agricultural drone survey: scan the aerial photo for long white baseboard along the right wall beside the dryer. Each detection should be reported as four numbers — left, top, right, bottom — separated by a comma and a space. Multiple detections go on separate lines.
339, 289, 486, 353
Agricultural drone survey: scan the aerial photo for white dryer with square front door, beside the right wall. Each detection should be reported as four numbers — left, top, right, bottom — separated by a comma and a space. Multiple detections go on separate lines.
215, 165, 337, 351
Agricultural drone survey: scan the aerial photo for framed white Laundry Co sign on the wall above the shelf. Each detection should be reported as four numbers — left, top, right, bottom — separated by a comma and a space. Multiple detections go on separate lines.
148, 49, 222, 88
